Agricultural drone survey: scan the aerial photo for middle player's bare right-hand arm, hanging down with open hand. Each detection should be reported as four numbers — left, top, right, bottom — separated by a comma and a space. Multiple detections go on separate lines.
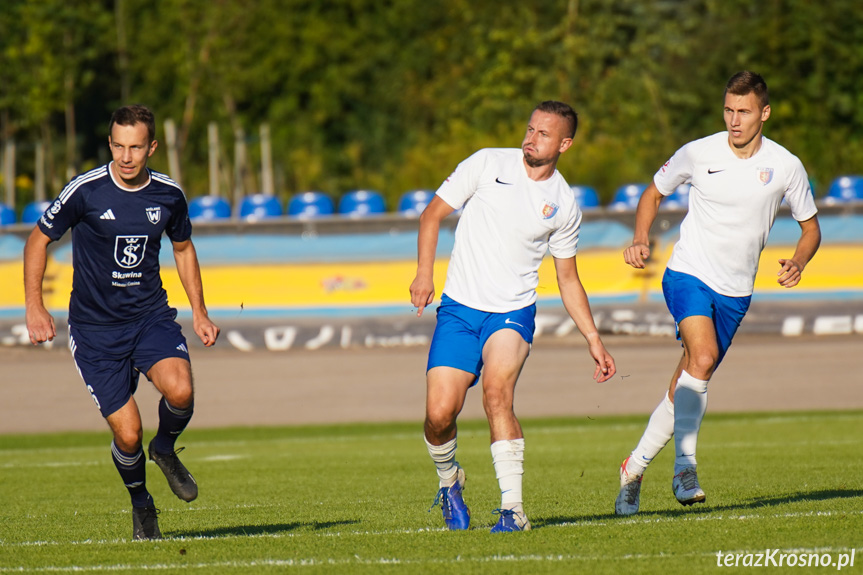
554, 256, 617, 383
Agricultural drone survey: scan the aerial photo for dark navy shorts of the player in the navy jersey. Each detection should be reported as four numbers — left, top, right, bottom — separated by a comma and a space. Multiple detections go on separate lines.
69, 308, 189, 417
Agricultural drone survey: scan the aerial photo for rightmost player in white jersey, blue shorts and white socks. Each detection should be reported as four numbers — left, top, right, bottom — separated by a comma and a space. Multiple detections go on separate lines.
615, 71, 821, 515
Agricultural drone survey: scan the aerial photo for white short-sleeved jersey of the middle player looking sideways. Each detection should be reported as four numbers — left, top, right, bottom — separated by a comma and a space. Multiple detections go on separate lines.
437, 148, 581, 313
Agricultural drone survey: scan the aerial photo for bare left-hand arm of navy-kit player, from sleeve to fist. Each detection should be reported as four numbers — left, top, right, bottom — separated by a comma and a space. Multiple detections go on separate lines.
24, 226, 57, 345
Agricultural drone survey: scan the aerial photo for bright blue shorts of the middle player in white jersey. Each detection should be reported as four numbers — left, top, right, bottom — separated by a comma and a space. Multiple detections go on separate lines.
426, 294, 536, 385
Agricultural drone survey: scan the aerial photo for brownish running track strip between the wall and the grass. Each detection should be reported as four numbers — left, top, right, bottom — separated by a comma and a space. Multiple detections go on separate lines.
0, 335, 863, 434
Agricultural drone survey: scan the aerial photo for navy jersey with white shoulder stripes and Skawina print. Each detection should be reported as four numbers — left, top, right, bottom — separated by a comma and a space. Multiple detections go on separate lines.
38, 164, 192, 325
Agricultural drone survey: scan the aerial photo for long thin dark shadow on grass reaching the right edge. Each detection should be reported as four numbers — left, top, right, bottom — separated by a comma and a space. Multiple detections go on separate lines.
531, 489, 863, 528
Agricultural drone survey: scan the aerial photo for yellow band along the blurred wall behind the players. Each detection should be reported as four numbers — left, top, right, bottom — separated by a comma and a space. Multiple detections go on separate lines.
8, 245, 863, 311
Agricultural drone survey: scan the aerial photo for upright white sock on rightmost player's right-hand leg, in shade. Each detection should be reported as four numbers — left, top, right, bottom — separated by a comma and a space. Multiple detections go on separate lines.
674, 371, 707, 475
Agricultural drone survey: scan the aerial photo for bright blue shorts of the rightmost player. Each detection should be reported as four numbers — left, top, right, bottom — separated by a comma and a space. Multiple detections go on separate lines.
662, 269, 752, 366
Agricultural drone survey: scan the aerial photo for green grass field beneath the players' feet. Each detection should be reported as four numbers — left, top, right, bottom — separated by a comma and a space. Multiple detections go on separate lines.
0, 412, 863, 575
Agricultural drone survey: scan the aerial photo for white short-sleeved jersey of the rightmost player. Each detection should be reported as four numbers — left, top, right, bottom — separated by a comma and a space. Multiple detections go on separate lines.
653, 132, 818, 297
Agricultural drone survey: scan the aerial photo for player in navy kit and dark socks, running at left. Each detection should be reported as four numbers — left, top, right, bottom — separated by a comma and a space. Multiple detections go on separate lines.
24, 105, 219, 539
